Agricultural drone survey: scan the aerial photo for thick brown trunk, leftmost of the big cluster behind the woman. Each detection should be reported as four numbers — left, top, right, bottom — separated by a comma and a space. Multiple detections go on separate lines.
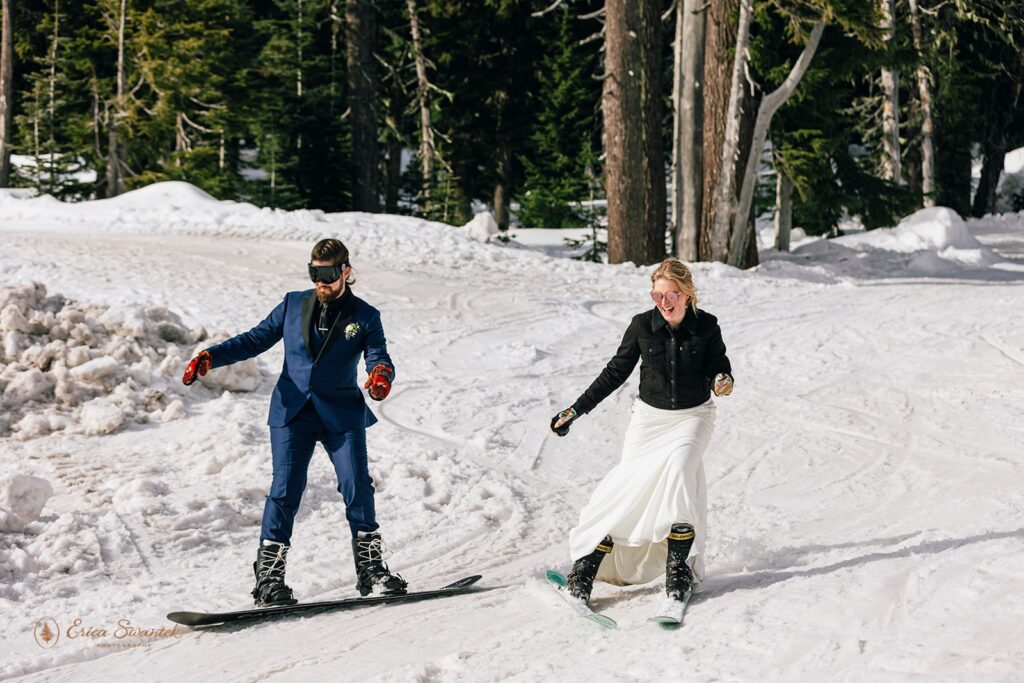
601, 0, 666, 265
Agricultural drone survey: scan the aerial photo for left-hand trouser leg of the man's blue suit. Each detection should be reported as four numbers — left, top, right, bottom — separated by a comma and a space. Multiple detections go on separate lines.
260, 408, 323, 544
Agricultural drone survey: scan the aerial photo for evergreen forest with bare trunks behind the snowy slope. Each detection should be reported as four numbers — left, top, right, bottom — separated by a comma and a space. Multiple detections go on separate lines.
0, 0, 1024, 267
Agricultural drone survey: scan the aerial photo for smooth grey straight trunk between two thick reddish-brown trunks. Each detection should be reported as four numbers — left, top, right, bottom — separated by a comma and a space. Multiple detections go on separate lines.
672, 0, 708, 261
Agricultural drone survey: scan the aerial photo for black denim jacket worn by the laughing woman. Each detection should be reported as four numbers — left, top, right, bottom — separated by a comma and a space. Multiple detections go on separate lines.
572, 308, 732, 415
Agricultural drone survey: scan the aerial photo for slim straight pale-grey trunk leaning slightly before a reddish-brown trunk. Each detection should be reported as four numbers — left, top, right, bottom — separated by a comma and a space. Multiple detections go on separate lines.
711, 0, 761, 261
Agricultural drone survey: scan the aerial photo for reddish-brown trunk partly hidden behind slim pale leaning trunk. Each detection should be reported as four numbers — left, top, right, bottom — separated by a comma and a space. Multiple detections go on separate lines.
697, 0, 755, 261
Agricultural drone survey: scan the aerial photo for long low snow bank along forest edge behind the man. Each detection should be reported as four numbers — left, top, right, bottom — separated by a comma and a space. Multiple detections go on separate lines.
0, 181, 635, 294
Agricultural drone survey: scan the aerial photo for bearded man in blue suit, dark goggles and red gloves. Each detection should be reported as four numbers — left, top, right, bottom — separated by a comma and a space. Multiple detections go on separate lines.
182, 240, 407, 607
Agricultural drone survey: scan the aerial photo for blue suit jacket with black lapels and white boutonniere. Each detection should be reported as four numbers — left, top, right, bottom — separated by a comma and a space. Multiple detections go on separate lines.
208, 290, 394, 432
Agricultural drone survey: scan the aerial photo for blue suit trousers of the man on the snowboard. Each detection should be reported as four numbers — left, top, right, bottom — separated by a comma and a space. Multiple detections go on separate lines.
260, 401, 378, 544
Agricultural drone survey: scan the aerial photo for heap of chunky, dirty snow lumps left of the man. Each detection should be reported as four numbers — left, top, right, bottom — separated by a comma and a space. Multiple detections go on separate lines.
0, 283, 262, 440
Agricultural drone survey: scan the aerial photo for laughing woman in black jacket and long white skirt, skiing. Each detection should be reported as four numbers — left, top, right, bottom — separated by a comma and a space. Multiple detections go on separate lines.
551, 259, 732, 602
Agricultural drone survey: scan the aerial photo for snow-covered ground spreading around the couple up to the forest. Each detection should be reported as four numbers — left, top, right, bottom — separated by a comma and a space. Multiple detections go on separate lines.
0, 183, 1024, 681
